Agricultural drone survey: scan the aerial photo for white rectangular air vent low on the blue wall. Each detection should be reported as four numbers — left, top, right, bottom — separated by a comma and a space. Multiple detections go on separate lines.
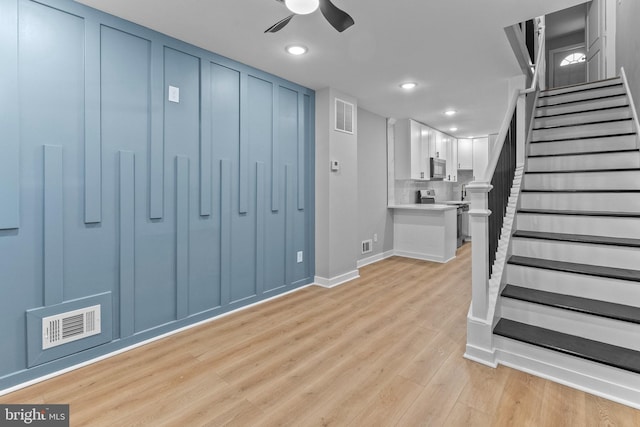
42, 305, 100, 350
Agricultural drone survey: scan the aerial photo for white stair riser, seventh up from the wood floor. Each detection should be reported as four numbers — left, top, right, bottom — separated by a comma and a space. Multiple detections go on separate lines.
523, 170, 640, 190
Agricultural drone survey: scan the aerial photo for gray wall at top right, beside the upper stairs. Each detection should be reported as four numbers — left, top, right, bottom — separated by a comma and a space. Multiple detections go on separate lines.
616, 0, 640, 115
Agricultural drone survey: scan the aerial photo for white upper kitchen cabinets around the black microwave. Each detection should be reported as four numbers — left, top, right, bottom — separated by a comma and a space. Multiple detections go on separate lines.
395, 119, 458, 182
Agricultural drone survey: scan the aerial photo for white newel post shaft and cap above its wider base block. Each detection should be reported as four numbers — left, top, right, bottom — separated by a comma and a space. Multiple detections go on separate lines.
467, 181, 493, 320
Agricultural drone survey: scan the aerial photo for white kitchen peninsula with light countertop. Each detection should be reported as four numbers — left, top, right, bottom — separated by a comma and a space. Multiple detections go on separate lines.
388, 204, 457, 262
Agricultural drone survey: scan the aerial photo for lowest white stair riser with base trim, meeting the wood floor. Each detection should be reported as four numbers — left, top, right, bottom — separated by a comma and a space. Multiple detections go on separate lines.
494, 336, 640, 409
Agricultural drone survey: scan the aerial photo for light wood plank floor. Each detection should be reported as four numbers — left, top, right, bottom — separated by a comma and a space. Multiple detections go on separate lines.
0, 244, 640, 427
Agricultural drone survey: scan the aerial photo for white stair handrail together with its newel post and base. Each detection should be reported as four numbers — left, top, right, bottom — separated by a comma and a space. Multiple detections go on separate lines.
465, 20, 545, 365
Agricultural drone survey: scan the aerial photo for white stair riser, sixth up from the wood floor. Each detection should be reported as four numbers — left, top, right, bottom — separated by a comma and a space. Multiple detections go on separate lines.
520, 193, 640, 213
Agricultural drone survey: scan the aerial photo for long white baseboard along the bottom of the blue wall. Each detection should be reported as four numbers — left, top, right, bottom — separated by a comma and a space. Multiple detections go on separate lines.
0, 283, 314, 396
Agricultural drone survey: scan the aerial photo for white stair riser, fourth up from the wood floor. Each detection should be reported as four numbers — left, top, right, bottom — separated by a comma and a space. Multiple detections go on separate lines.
511, 237, 640, 269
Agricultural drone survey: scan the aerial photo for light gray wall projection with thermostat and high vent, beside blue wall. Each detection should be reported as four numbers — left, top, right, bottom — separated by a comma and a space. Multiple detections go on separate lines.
316, 88, 359, 286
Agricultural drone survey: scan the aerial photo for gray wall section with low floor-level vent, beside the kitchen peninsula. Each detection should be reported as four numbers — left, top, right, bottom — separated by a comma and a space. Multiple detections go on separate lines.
357, 108, 393, 260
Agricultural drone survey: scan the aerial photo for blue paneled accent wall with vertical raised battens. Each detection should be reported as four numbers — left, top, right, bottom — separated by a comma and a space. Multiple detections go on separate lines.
0, 0, 315, 389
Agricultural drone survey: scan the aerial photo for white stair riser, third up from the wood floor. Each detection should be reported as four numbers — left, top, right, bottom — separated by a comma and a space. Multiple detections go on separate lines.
506, 264, 640, 306
